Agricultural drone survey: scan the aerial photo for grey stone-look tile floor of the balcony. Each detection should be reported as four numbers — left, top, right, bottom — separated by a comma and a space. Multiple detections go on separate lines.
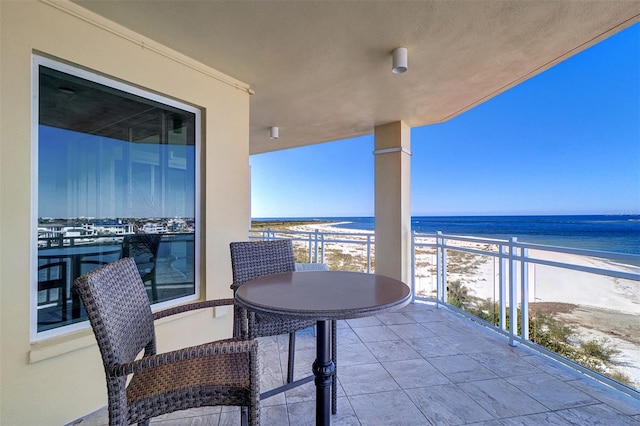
72, 303, 640, 426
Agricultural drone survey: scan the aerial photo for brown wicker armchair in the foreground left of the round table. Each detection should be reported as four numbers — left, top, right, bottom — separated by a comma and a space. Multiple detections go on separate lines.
74, 258, 260, 425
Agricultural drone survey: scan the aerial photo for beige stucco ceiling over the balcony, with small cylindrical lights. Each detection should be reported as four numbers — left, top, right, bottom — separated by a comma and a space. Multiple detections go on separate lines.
76, 0, 640, 154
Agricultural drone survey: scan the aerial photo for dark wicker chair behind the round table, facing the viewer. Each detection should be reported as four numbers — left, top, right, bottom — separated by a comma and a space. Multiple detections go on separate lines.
230, 240, 338, 414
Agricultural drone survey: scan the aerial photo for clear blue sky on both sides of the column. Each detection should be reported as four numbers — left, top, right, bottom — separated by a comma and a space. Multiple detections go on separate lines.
250, 24, 640, 218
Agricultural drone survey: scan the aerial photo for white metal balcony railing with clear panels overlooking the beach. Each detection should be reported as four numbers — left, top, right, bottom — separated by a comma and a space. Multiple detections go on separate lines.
249, 229, 640, 399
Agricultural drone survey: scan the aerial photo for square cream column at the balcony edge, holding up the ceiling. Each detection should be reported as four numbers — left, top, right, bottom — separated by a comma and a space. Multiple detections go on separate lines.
374, 121, 411, 285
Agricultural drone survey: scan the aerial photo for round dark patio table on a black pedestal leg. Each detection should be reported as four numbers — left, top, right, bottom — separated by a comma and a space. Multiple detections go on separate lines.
235, 271, 411, 425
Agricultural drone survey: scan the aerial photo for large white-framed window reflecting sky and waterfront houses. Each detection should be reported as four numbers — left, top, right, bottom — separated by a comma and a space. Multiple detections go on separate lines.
32, 56, 200, 338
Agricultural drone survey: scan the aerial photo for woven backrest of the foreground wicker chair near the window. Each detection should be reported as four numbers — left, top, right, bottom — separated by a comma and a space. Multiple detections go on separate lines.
74, 258, 155, 369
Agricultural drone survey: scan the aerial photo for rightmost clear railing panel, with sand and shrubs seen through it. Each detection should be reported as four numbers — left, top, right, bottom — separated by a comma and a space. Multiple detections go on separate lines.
529, 252, 640, 390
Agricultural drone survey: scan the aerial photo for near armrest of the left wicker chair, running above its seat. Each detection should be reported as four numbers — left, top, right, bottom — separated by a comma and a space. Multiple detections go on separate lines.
107, 339, 258, 377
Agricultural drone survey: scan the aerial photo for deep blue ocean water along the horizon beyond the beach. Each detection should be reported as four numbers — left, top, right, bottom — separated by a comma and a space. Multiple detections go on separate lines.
255, 215, 640, 255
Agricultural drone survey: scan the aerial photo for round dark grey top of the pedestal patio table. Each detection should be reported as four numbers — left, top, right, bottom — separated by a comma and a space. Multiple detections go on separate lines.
235, 271, 411, 320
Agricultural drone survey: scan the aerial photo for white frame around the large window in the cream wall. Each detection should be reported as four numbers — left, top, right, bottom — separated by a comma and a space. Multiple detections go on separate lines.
29, 53, 203, 342
